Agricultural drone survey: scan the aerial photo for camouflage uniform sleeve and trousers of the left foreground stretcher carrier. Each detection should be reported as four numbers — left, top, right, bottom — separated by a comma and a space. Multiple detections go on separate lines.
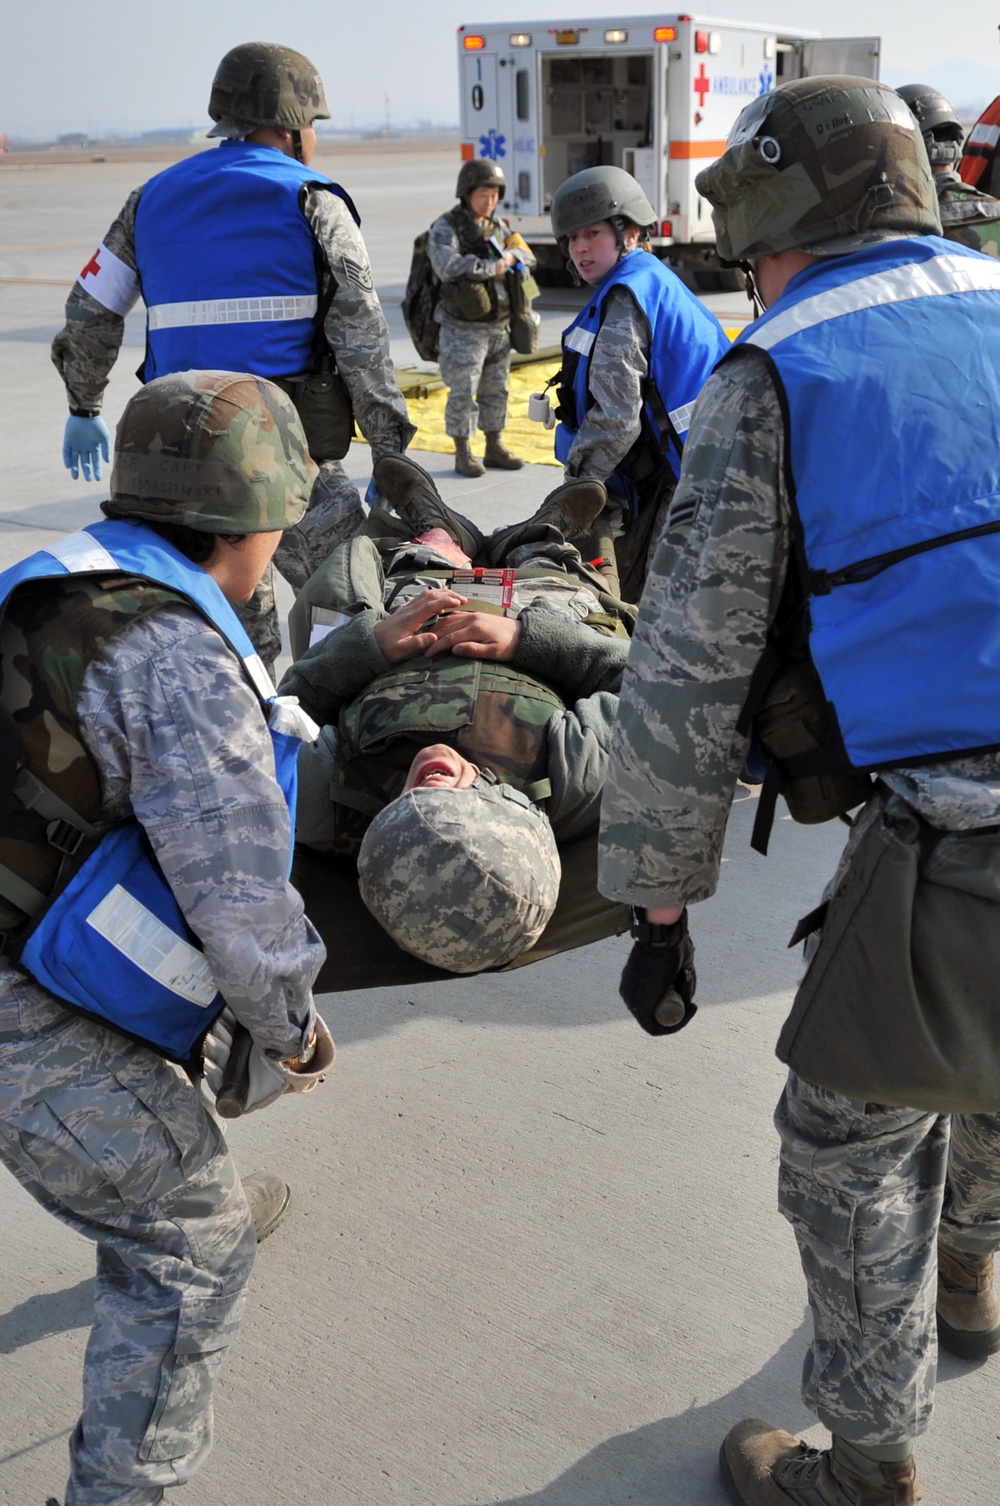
0, 605, 324, 1506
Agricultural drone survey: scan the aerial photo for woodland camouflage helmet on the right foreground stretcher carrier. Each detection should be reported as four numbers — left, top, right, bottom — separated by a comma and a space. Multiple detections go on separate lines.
694, 75, 941, 264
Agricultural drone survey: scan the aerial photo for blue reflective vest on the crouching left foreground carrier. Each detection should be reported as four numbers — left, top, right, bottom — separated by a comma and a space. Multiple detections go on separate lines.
0, 521, 300, 1062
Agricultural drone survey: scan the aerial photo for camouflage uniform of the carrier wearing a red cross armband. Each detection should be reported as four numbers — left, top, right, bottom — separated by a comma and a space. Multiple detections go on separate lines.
45, 179, 416, 666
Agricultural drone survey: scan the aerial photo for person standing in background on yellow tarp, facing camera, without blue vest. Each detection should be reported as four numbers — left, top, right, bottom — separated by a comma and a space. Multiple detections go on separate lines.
428, 157, 535, 476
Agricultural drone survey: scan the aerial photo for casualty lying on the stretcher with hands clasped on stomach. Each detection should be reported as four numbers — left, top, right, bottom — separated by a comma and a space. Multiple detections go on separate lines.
282, 455, 633, 973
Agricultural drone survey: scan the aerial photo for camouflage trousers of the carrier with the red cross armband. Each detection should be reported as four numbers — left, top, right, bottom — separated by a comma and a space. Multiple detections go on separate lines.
236, 461, 364, 673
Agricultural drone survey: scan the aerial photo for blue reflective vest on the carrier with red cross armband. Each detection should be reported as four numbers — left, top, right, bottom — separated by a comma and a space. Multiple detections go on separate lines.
136, 142, 360, 381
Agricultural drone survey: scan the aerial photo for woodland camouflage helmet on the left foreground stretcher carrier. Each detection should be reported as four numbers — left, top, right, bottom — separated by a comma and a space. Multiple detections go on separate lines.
104, 372, 316, 533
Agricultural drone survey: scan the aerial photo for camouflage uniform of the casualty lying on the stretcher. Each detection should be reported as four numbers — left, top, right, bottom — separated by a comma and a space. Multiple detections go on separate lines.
282, 526, 628, 849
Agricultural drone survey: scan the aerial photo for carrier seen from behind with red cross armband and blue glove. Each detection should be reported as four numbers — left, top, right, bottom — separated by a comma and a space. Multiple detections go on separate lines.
53, 42, 416, 667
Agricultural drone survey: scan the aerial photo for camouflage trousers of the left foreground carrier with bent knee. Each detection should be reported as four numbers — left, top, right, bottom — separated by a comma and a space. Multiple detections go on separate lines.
0, 962, 256, 1506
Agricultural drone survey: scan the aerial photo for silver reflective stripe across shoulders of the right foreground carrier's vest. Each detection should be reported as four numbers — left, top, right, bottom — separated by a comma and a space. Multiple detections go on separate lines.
741, 255, 1000, 351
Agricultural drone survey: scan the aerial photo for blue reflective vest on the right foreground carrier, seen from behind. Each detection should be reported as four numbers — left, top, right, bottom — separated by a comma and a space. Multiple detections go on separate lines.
727, 236, 1000, 774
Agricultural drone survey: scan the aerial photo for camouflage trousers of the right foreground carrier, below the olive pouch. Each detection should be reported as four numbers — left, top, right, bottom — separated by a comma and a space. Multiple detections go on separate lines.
774, 1072, 1000, 1444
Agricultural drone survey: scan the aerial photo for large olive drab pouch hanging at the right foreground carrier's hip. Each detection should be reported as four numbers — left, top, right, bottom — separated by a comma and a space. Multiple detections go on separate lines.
777, 794, 1000, 1114
